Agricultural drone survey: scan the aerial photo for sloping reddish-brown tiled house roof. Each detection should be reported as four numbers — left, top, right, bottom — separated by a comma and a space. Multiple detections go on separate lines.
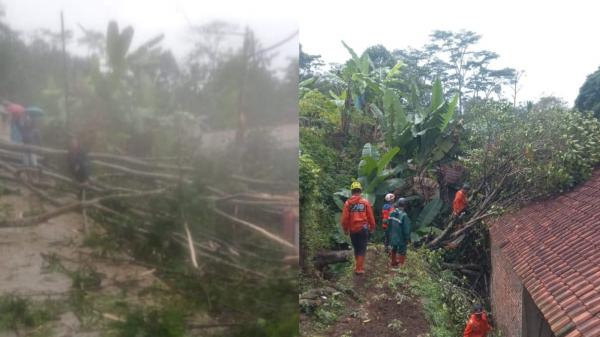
490, 170, 600, 337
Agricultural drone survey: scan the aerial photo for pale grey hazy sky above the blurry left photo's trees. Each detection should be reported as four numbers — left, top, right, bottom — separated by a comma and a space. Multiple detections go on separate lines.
0, 0, 298, 71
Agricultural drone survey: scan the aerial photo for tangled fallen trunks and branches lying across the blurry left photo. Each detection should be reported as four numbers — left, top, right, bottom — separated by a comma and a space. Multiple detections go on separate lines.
0, 141, 298, 278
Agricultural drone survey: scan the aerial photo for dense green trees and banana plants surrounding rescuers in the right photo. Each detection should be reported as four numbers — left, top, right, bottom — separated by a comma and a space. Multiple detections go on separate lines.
300, 31, 600, 336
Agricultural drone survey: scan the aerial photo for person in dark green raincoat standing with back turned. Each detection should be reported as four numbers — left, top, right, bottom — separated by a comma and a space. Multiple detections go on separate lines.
388, 198, 410, 268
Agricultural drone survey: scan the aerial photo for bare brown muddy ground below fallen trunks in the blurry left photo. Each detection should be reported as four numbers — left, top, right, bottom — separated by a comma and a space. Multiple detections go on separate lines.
0, 190, 157, 337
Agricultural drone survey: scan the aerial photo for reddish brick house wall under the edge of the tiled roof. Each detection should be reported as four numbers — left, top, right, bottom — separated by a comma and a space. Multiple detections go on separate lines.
491, 236, 523, 337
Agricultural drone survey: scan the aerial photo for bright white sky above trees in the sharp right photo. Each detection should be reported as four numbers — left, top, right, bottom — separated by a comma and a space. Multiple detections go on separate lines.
298, 0, 600, 104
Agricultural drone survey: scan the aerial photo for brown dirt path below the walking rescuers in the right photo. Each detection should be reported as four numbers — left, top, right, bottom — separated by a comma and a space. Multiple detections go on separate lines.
327, 246, 429, 337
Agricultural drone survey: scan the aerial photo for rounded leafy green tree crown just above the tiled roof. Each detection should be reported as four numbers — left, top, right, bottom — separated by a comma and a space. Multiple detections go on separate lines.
464, 98, 600, 198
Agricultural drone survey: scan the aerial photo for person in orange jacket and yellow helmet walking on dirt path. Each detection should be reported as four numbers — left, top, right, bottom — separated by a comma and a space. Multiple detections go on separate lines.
341, 181, 375, 274
